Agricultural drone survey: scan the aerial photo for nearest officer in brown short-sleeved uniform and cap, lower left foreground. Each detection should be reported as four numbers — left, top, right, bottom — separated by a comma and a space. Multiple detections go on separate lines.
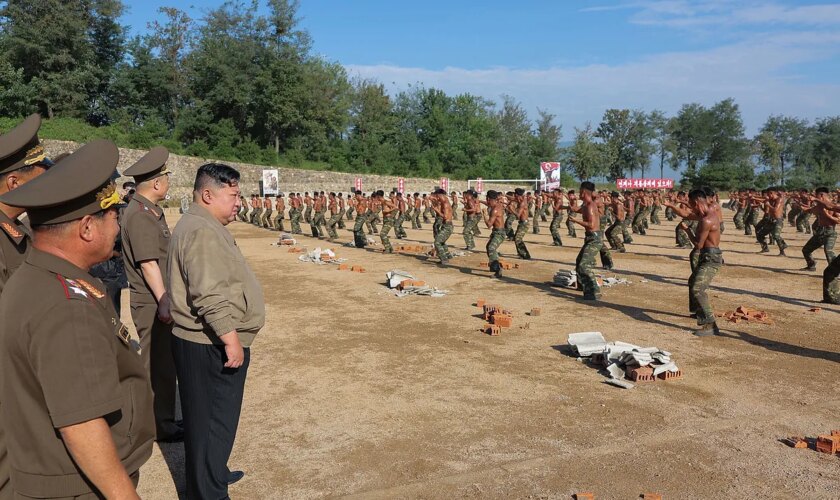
0, 140, 154, 499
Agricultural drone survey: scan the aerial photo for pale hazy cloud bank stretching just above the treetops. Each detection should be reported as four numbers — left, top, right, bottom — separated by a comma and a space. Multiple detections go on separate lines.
348, 31, 840, 139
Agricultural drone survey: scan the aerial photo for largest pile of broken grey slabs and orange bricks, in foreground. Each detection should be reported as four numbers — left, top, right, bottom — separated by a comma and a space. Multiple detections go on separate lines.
568, 332, 682, 389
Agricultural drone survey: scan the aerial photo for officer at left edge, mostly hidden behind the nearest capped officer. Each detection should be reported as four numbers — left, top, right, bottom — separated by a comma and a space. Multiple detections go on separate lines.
0, 115, 52, 500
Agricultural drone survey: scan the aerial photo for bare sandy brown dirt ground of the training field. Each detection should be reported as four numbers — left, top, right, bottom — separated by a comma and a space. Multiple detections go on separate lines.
135, 206, 840, 499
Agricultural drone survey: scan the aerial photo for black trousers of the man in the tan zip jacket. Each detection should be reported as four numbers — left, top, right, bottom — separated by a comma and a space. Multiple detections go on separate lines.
172, 336, 251, 500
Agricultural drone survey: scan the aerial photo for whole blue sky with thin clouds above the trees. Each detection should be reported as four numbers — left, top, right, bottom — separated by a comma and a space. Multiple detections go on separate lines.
124, 0, 840, 139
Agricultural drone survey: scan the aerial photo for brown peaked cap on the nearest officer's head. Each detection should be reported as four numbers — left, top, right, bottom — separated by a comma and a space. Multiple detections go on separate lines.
0, 139, 120, 225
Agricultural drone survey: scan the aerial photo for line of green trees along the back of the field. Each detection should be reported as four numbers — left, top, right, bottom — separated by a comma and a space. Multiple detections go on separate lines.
0, 0, 840, 189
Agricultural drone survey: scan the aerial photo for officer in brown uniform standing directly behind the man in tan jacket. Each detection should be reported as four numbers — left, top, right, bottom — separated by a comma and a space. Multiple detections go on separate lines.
121, 147, 184, 441
